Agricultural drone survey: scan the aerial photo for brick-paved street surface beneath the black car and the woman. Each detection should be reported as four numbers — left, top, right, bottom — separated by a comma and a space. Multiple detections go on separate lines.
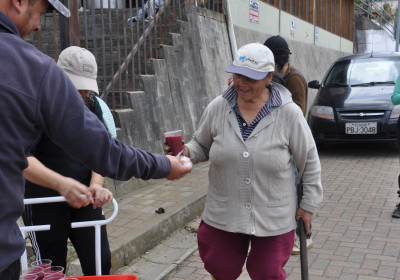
164, 144, 400, 280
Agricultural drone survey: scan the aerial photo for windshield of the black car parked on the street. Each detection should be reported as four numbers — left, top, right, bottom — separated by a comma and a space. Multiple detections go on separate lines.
325, 57, 400, 86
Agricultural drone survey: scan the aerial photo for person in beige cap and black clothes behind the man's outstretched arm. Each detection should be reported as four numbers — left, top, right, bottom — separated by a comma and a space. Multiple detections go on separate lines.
22, 46, 115, 276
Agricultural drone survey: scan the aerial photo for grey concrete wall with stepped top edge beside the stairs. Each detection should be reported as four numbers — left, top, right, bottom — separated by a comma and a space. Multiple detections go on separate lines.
107, 6, 349, 196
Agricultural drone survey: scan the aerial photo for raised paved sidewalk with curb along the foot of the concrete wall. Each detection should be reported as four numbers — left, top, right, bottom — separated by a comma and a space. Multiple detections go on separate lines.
68, 162, 209, 276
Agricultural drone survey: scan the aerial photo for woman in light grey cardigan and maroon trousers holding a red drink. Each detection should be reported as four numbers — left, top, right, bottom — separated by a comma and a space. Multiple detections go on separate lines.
165, 43, 323, 280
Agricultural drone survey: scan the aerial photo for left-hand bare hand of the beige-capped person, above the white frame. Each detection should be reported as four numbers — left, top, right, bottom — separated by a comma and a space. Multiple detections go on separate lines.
57, 177, 93, 208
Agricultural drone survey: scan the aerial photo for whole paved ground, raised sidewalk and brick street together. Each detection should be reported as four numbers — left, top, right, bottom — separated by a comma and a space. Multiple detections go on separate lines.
66, 144, 400, 280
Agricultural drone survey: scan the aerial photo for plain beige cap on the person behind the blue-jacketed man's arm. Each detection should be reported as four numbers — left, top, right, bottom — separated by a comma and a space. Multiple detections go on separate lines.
57, 46, 99, 94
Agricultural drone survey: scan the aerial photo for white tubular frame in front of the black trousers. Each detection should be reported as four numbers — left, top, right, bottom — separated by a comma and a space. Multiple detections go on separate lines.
20, 196, 118, 275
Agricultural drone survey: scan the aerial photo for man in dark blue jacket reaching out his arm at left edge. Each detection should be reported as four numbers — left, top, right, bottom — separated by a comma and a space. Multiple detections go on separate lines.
0, 0, 191, 280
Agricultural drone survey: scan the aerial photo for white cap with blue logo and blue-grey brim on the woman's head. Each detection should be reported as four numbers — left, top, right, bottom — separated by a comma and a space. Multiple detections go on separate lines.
225, 43, 275, 80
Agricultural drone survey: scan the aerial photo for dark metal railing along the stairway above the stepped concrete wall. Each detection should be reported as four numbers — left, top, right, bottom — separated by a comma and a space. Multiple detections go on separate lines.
26, 0, 226, 109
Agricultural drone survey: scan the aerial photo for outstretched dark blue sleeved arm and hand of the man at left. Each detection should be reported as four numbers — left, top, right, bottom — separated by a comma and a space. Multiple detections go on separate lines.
34, 62, 191, 180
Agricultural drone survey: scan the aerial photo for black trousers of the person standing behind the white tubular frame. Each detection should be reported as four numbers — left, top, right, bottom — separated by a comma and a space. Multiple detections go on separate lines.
23, 203, 111, 276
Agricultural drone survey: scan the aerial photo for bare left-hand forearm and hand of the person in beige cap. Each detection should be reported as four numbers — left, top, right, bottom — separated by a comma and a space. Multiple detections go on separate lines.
24, 156, 93, 208
